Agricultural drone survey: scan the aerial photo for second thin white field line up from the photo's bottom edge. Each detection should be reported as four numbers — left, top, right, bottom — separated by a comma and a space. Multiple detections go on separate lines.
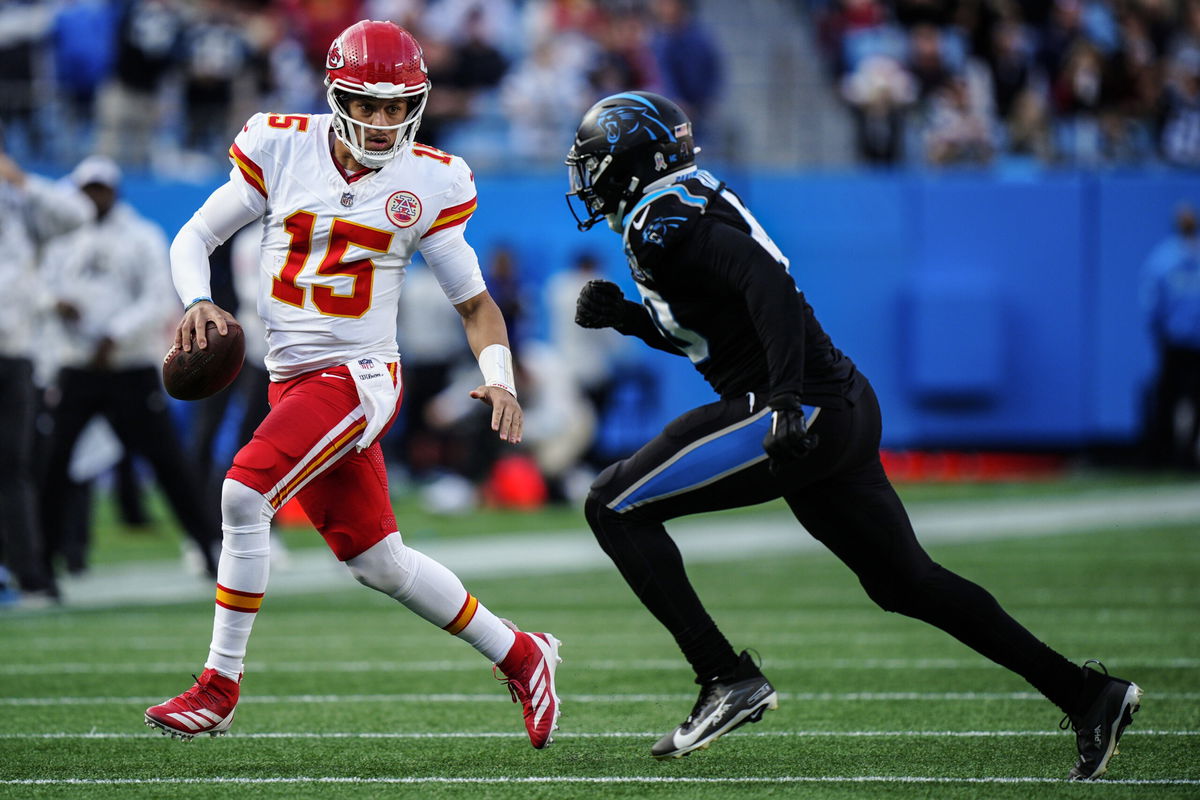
0, 728, 1200, 740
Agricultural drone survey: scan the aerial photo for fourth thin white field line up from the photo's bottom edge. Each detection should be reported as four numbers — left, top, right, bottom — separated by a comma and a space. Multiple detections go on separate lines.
7, 657, 1200, 675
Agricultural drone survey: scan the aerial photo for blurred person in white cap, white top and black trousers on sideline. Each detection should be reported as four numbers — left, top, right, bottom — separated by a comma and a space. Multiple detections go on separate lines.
41, 156, 221, 576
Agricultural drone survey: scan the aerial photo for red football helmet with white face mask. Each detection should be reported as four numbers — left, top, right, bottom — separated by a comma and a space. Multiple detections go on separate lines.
325, 19, 430, 168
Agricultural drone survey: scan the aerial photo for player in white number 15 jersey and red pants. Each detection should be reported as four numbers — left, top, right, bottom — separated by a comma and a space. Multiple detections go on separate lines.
145, 20, 559, 748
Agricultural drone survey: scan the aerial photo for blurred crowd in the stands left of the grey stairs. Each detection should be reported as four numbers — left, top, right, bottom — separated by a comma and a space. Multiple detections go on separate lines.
0, 0, 721, 174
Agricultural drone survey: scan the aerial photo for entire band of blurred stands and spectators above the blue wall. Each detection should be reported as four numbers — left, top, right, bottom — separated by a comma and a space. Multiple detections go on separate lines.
11, 0, 1200, 170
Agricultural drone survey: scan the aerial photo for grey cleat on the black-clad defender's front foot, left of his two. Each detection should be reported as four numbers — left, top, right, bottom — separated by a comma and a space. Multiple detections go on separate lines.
650, 650, 779, 759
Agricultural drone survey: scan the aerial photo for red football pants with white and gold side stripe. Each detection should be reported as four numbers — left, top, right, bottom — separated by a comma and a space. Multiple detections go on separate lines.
226, 363, 403, 561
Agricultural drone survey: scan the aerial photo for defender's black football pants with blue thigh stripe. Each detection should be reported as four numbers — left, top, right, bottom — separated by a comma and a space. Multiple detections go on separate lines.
586, 379, 1082, 710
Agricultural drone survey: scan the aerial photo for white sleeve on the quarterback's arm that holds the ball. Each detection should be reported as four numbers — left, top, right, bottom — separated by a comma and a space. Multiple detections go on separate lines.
170, 181, 266, 306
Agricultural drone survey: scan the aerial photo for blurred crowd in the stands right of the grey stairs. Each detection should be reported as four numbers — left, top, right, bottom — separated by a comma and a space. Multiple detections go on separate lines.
805, 0, 1200, 168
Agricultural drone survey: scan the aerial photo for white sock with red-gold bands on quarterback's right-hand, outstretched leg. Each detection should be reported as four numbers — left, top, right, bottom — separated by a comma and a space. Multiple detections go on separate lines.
346, 534, 515, 663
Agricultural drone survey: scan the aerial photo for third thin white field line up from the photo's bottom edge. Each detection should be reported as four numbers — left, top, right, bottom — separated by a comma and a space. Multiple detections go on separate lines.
0, 692, 1200, 706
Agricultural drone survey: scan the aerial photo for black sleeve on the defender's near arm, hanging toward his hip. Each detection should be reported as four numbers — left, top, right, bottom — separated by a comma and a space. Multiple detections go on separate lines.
682, 222, 805, 396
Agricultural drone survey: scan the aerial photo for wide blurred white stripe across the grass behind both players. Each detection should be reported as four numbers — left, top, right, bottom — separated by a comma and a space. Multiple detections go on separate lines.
42, 487, 1200, 607
